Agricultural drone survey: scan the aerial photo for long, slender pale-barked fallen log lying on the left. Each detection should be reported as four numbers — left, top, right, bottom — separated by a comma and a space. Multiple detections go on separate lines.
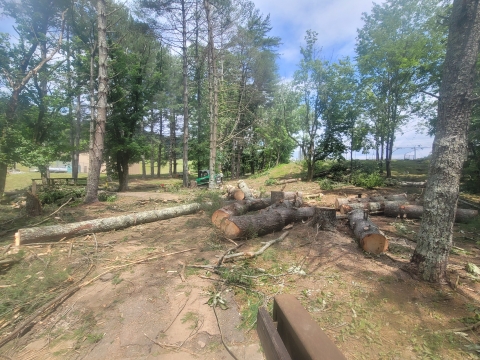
15, 203, 201, 246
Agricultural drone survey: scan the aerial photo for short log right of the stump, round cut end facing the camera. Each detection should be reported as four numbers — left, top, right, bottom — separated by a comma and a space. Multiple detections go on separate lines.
348, 209, 388, 254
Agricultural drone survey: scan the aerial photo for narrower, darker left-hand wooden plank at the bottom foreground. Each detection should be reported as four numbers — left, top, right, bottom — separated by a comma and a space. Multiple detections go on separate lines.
257, 307, 292, 360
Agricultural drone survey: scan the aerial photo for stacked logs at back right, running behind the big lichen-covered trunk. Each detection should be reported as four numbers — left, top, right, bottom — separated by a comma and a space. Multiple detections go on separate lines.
335, 194, 478, 222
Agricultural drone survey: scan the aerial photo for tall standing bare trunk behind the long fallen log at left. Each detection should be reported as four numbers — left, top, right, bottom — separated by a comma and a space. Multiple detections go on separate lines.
85, 0, 108, 204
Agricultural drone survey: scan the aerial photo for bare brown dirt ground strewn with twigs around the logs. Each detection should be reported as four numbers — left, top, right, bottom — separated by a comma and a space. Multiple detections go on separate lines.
0, 173, 480, 360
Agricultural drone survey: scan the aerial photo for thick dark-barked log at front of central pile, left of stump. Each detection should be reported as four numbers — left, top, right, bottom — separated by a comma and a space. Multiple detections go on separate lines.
221, 207, 315, 239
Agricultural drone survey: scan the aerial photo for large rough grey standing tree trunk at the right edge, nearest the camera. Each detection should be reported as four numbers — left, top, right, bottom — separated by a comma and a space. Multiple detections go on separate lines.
411, 0, 480, 282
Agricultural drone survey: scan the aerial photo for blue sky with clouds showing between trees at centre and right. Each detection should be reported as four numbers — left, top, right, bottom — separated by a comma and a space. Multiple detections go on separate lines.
253, 0, 433, 159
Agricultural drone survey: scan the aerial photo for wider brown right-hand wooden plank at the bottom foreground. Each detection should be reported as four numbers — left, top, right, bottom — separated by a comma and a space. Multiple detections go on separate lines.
273, 294, 346, 360
